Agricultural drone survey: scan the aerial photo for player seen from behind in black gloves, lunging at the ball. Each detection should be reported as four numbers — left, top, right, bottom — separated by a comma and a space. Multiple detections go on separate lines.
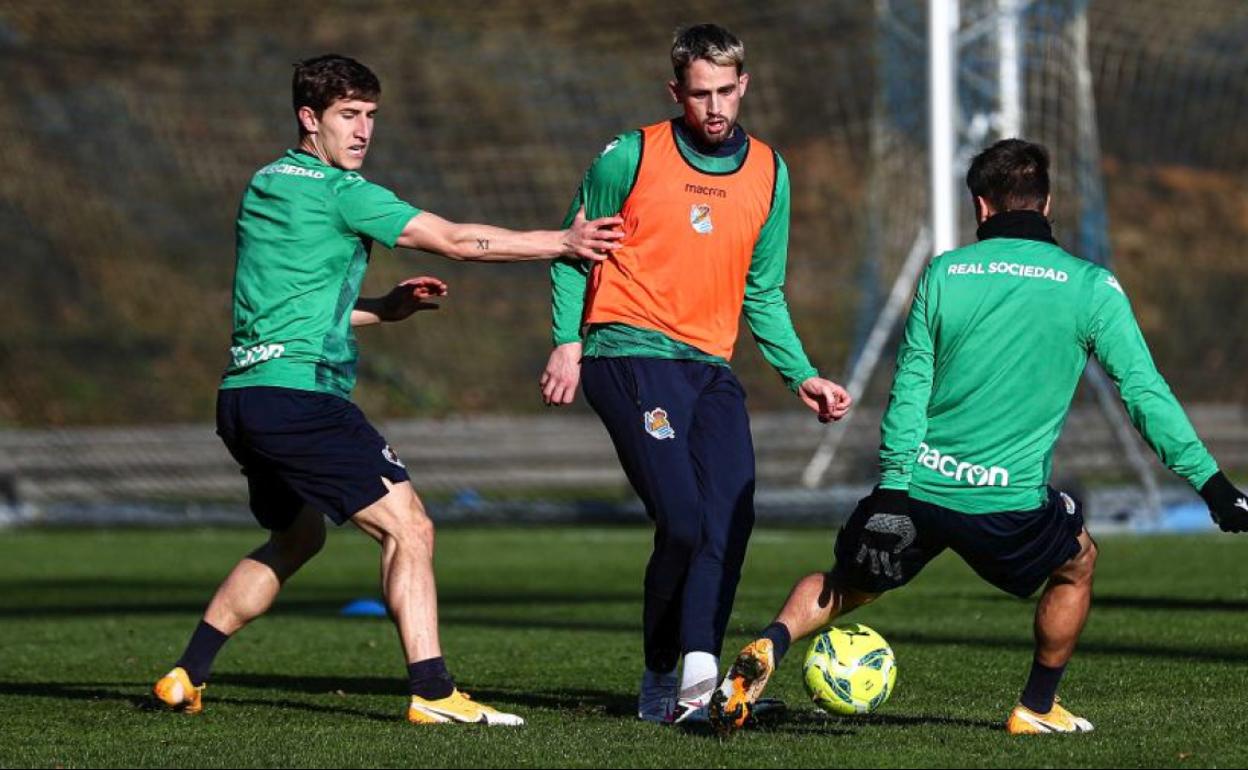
711, 140, 1248, 734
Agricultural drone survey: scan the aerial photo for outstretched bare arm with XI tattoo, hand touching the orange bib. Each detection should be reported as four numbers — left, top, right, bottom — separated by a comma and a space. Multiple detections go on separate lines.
396, 211, 623, 262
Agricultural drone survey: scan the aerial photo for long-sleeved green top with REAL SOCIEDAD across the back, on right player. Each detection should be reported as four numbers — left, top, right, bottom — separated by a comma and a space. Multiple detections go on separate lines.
880, 222, 1218, 514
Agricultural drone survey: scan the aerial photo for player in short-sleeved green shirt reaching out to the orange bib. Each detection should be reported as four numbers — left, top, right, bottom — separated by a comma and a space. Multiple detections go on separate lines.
155, 55, 619, 725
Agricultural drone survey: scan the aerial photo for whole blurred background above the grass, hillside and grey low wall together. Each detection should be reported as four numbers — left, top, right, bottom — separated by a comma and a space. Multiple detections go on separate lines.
0, 0, 1248, 527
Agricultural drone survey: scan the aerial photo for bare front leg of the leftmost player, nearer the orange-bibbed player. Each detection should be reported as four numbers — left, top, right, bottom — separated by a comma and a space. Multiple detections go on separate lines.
351, 479, 442, 663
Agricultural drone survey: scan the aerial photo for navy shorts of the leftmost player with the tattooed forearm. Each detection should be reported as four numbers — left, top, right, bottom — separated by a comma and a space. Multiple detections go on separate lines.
217, 387, 408, 530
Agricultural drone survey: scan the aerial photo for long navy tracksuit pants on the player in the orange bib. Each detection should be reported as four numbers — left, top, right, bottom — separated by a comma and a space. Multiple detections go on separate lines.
582, 358, 754, 671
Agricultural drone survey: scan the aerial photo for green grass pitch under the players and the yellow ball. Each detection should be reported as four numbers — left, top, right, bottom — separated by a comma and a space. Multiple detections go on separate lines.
0, 528, 1248, 768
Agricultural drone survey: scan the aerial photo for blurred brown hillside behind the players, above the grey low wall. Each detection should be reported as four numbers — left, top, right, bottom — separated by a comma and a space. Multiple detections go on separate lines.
0, 0, 1248, 427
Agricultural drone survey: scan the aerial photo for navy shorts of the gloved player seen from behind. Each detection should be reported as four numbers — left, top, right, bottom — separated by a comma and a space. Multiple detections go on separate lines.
832, 489, 1083, 598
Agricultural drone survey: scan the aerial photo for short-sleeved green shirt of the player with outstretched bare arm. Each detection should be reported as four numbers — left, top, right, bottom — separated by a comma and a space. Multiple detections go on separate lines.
221, 150, 421, 398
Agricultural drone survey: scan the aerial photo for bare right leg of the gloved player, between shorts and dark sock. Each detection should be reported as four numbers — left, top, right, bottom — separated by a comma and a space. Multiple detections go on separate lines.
1035, 529, 1097, 669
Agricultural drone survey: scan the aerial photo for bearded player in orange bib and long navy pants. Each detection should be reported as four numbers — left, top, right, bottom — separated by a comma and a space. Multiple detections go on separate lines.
540, 24, 850, 723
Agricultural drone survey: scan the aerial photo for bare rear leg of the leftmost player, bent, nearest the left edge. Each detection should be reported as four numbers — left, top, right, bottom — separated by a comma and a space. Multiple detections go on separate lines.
203, 508, 324, 636
